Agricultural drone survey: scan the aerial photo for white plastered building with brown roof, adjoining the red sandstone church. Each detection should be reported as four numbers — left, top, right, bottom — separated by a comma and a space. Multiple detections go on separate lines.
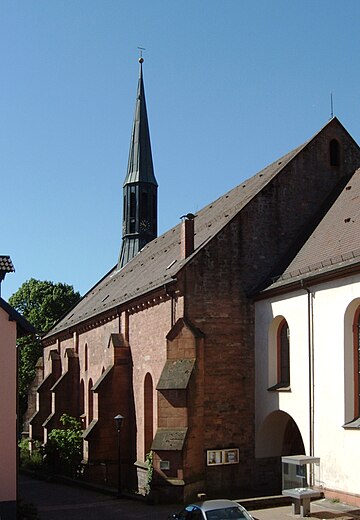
255, 165, 360, 507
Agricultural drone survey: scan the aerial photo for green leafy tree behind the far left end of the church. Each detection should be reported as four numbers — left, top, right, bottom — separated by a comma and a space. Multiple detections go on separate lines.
9, 278, 80, 416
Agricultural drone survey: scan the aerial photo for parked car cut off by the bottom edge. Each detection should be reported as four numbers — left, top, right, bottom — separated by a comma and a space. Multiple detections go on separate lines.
169, 499, 254, 520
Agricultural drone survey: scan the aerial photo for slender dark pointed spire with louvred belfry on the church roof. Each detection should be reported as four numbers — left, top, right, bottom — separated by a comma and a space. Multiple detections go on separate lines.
118, 57, 158, 269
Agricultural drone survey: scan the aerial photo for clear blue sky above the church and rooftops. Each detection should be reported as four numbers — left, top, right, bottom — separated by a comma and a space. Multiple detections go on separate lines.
0, 0, 360, 299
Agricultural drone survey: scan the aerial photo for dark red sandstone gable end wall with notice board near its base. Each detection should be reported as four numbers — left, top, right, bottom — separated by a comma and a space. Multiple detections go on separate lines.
183, 121, 360, 494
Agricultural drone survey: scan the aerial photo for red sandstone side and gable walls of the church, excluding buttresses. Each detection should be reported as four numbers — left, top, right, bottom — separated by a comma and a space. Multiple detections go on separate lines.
35, 121, 360, 502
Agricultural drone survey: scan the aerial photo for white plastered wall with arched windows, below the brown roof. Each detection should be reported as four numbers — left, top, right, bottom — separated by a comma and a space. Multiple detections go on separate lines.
255, 275, 360, 494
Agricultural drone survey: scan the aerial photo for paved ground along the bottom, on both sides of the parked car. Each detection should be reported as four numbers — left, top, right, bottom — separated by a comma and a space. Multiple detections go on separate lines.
19, 475, 360, 520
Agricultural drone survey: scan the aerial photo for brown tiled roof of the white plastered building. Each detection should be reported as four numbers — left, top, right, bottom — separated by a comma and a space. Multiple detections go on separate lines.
269, 169, 360, 289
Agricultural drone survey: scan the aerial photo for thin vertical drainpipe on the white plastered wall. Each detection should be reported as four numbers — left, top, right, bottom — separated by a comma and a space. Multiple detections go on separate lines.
301, 280, 314, 464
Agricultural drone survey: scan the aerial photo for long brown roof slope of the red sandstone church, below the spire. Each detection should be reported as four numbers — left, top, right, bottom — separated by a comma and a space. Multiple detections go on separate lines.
45, 141, 310, 338
